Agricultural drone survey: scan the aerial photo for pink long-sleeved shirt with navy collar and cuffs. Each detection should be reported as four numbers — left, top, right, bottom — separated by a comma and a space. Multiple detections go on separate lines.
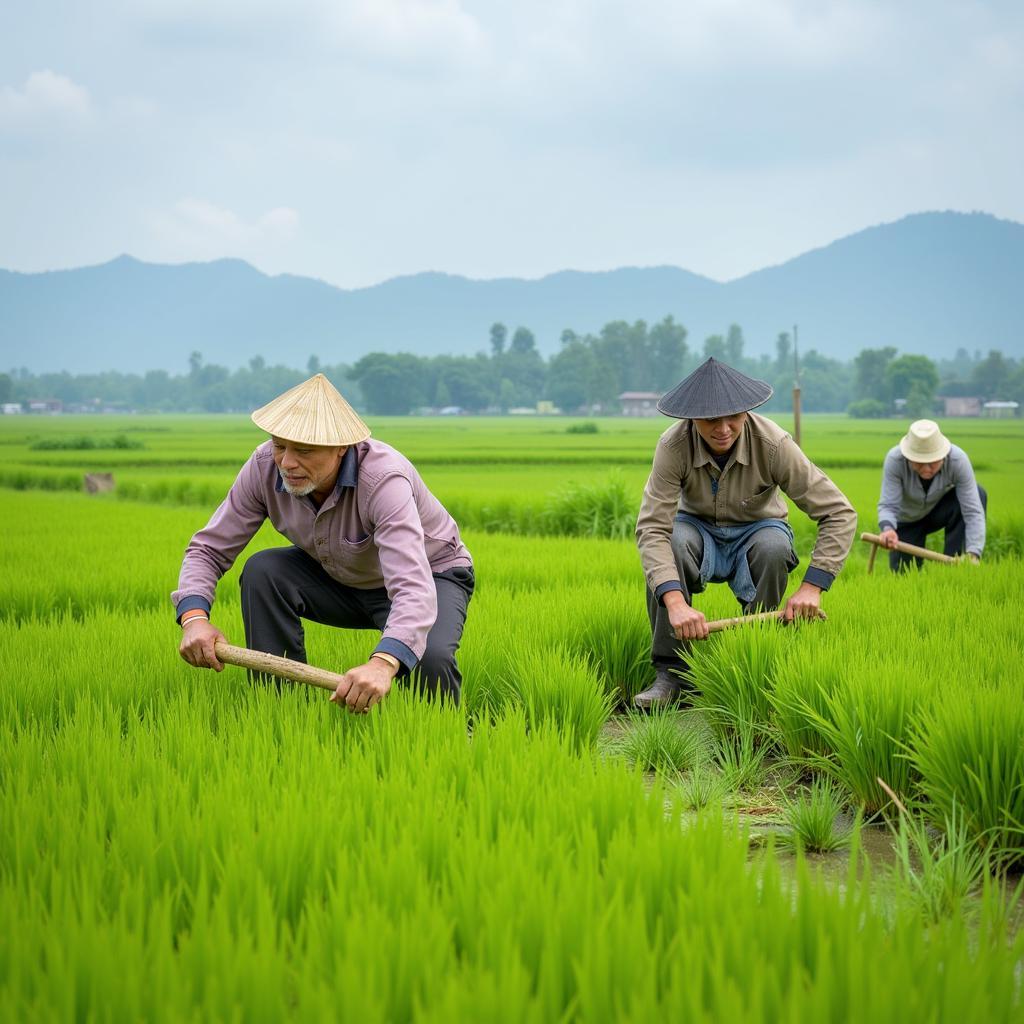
171, 438, 473, 667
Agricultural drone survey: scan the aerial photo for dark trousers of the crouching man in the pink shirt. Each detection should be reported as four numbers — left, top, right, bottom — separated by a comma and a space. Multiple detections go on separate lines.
240, 547, 474, 702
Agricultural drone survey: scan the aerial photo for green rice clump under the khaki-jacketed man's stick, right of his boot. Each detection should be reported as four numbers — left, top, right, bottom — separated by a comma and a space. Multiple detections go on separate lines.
686, 623, 786, 742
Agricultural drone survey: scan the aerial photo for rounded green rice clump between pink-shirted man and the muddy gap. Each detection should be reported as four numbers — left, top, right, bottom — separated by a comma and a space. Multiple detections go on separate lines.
499, 645, 611, 750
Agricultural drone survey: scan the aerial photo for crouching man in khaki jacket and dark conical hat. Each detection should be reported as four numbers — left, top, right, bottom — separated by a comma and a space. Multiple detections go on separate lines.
635, 358, 857, 708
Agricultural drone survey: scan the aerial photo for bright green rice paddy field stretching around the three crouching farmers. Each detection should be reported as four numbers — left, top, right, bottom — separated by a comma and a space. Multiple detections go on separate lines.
0, 417, 1024, 1024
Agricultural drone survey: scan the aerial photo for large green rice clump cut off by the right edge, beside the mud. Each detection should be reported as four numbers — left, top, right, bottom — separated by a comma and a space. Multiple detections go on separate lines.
909, 682, 1024, 867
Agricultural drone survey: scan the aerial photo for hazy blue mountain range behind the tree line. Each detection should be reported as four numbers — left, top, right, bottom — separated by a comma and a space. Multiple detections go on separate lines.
0, 212, 1024, 373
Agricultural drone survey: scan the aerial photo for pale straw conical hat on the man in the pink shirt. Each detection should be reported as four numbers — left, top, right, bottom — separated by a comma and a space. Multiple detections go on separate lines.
252, 374, 370, 445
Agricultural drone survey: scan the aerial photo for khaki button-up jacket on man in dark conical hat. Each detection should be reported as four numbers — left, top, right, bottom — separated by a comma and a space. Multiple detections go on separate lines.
636, 413, 857, 591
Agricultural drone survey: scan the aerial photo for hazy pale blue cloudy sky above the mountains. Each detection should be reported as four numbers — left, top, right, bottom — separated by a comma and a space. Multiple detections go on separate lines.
0, 0, 1024, 288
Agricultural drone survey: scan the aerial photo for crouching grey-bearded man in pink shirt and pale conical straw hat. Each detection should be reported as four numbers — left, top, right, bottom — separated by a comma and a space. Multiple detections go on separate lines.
171, 374, 474, 712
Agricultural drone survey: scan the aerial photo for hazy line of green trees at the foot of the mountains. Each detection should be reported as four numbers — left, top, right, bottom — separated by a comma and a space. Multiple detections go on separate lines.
0, 316, 1024, 416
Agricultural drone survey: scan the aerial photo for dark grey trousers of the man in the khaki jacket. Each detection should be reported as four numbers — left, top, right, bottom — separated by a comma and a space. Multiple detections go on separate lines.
647, 522, 797, 669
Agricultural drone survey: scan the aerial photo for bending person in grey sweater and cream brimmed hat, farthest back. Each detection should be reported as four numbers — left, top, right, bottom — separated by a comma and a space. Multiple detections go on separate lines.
879, 420, 988, 572
